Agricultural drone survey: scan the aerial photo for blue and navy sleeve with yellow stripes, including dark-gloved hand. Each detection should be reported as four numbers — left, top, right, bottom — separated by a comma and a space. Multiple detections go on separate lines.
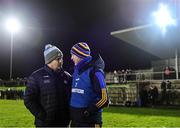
87, 71, 109, 113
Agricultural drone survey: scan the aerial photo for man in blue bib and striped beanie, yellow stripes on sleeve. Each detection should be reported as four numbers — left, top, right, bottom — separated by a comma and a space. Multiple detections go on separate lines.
70, 42, 108, 127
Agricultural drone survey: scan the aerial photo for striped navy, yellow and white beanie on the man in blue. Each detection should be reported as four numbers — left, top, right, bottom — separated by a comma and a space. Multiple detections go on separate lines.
71, 42, 91, 59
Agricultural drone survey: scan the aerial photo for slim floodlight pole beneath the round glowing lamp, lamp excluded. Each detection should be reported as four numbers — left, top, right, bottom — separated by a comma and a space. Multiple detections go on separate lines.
9, 31, 14, 80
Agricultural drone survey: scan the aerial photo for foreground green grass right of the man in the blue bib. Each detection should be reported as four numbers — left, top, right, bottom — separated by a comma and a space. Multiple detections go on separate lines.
103, 107, 180, 127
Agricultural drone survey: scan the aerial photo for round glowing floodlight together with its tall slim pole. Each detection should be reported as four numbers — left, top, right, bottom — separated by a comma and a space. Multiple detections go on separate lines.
6, 18, 20, 80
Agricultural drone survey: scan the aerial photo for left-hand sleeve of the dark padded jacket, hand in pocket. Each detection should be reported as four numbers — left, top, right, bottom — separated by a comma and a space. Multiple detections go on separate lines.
24, 76, 45, 120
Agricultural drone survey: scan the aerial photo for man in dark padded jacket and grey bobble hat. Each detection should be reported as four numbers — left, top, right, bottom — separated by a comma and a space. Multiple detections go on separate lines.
24, 44, 71, 127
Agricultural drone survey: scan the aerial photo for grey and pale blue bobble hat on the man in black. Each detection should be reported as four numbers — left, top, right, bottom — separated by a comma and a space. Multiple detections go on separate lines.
44, 44, 63, 64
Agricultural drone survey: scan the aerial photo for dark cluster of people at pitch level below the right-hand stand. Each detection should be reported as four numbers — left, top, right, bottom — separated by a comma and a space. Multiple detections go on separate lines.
139, 80, 176, 107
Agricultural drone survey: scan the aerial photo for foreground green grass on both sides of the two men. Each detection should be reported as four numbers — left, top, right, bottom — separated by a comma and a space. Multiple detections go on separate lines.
0, 100, 180, 127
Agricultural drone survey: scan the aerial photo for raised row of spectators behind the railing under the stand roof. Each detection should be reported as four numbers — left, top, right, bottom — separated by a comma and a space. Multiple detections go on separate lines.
106, 66, 176, 84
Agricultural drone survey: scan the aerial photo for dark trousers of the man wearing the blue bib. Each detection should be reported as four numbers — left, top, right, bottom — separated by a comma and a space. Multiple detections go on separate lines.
70, 107, 102, 127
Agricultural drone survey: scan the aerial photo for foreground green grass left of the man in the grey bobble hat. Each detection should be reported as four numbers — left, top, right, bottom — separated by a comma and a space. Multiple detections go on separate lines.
0, 100, 34, 127
